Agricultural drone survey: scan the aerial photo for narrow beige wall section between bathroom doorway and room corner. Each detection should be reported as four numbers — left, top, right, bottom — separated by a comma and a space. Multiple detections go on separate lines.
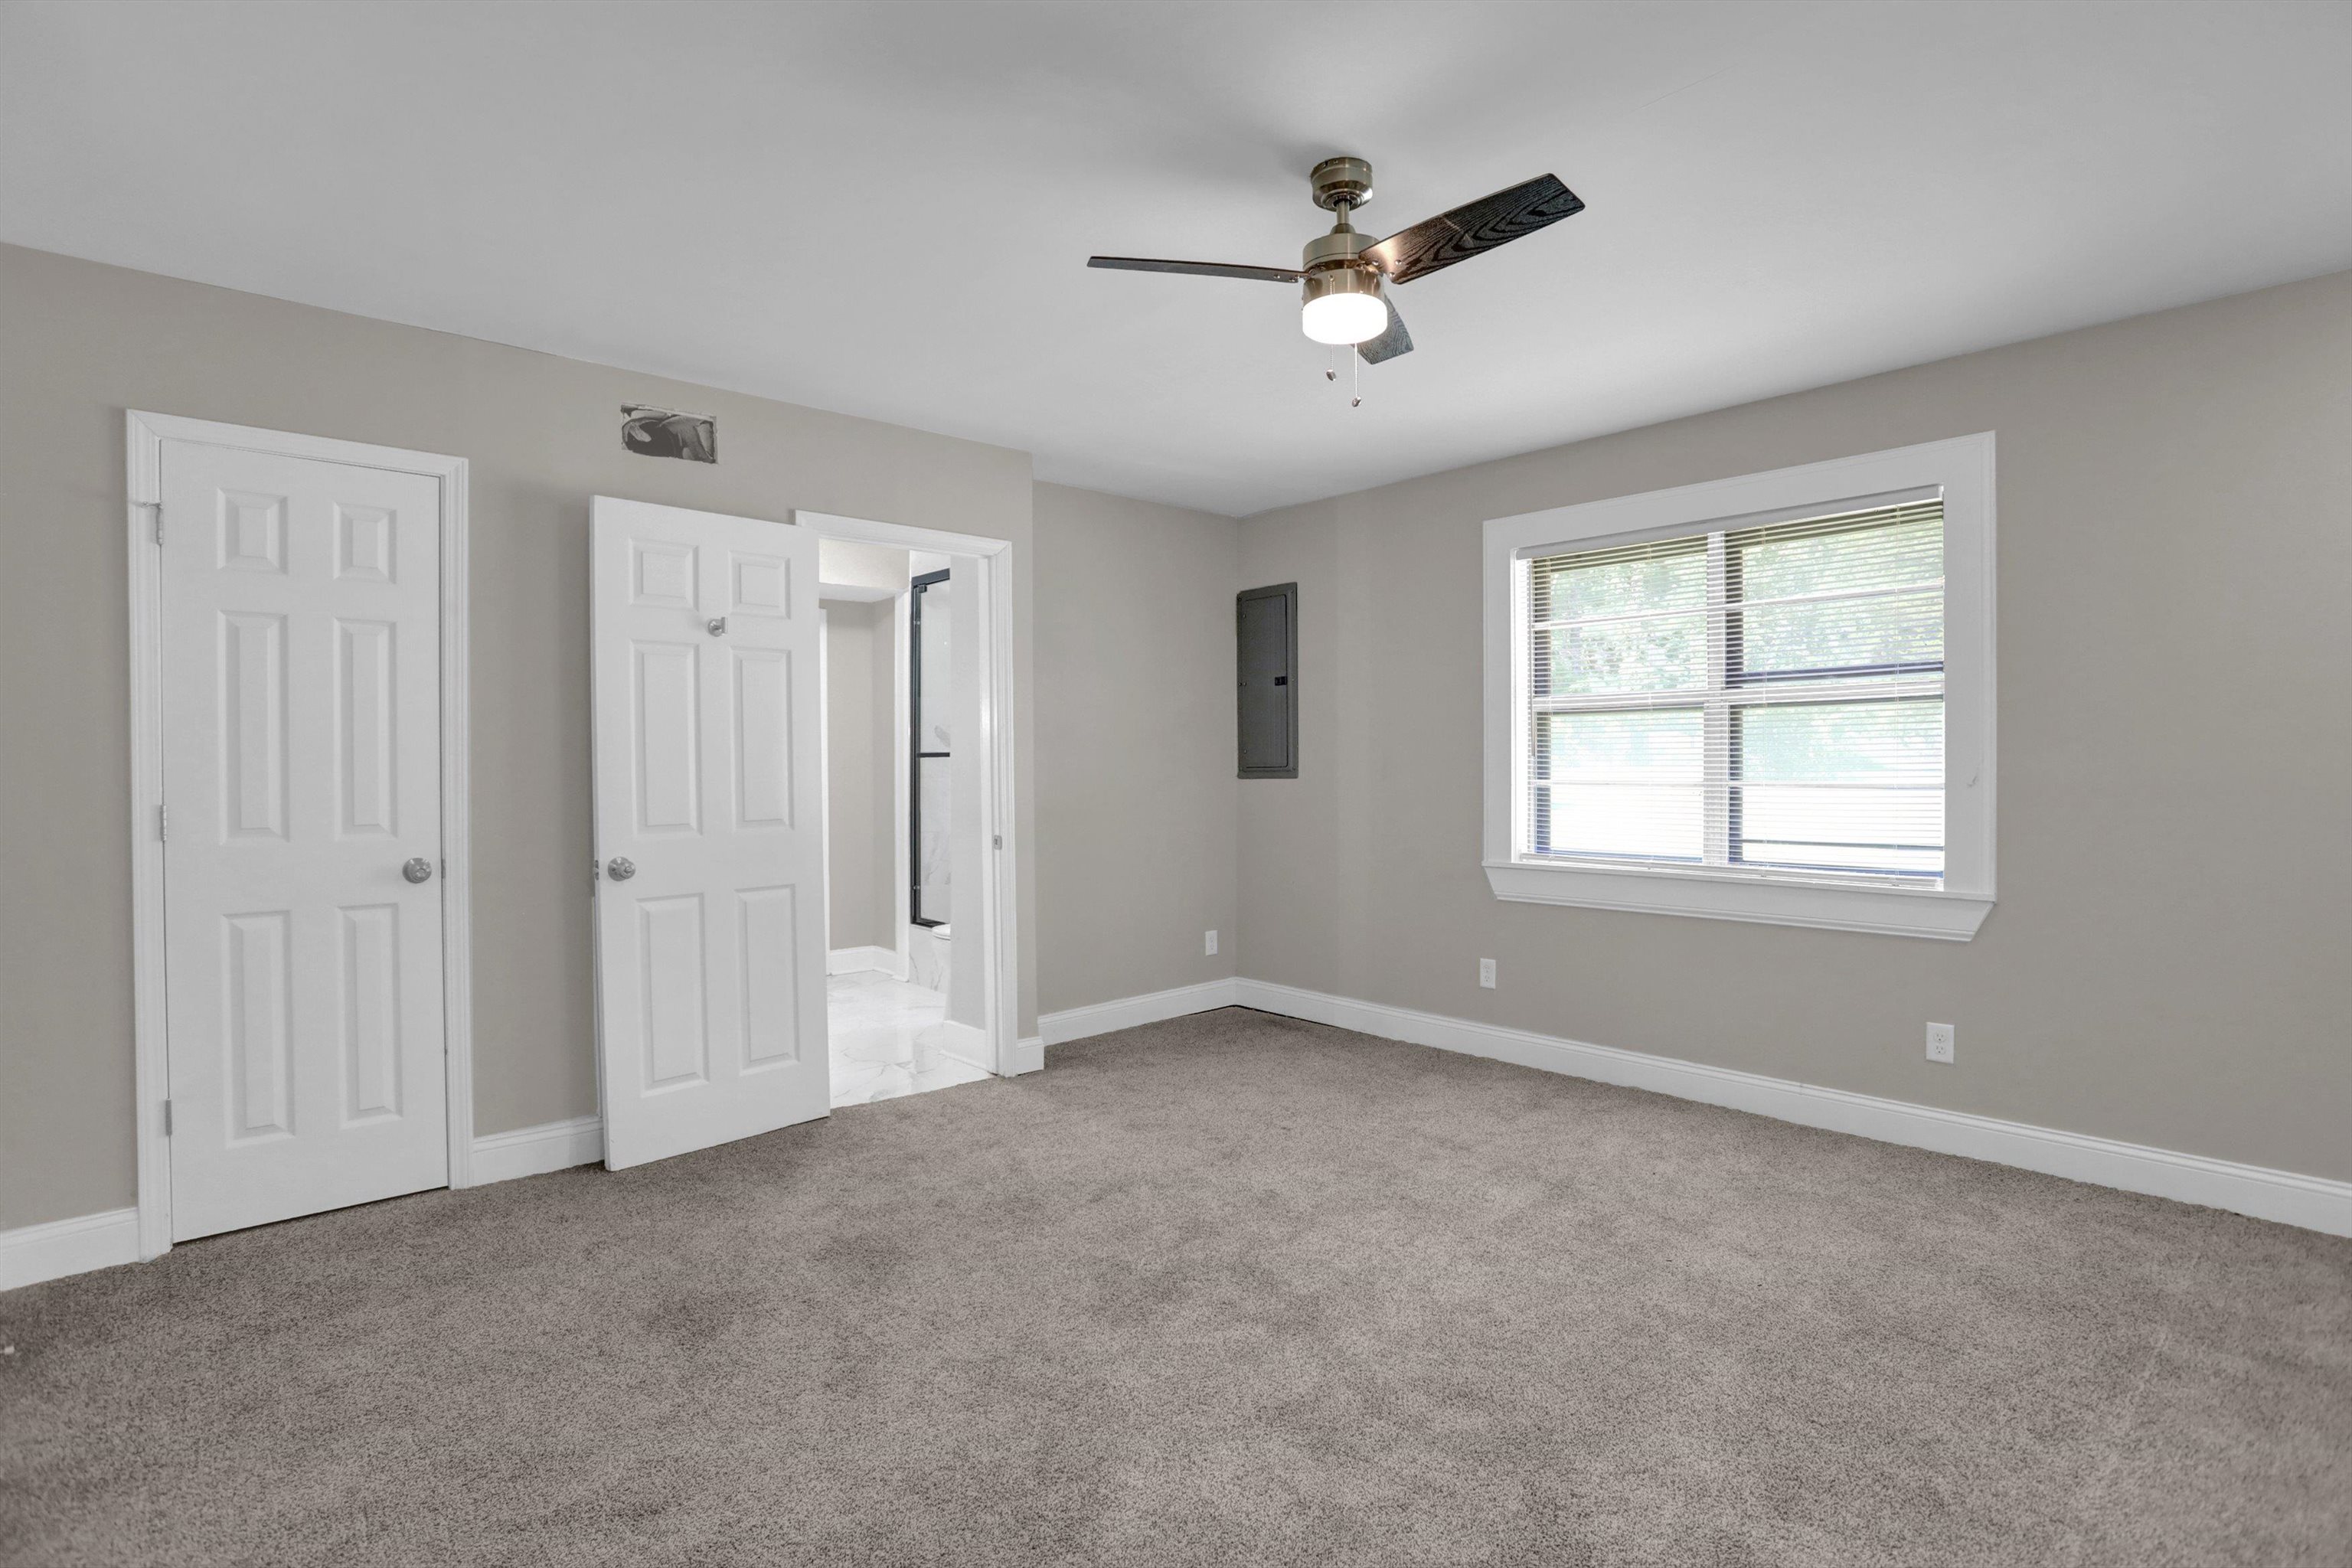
1037, 485, 1253, 1013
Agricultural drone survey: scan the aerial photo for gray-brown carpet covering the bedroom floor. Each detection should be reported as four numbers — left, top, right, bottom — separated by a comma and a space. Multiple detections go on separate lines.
0, 1011, 2352, 1568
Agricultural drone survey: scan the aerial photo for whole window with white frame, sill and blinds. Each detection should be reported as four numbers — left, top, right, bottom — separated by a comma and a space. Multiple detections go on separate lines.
1487, 435, 1992, 938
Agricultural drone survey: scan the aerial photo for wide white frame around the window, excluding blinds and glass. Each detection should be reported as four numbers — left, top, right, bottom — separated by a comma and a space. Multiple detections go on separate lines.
1481, 430, 1994, 942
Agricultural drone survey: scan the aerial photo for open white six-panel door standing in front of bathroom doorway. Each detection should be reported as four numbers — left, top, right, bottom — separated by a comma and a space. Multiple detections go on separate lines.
593, 496, 830, 1171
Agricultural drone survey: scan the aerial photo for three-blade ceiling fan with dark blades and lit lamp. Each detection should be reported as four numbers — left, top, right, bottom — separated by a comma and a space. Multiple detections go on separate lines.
1086, 158, 1586, 364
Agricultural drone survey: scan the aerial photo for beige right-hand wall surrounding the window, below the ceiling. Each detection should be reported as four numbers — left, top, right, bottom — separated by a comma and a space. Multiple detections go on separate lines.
1242, 273, 2352, 1178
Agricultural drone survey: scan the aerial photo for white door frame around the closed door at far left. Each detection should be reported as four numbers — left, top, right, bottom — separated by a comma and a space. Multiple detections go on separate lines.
122, 409, 472, 1260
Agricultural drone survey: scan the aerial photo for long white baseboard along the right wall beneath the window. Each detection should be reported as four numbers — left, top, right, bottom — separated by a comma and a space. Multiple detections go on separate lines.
1223, 980, 2352, 1236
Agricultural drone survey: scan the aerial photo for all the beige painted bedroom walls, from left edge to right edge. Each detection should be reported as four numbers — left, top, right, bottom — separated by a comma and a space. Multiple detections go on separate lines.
0, 247, 2352, 1227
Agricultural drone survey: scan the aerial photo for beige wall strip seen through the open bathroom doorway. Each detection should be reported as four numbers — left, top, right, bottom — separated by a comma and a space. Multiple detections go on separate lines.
825, 596, 906, 947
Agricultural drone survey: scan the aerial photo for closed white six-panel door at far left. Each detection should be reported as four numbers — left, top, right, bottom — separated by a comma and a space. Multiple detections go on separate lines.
160, 439, 449, 1241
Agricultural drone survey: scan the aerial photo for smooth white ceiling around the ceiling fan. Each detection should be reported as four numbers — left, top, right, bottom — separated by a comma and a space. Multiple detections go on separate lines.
0, 0, 2352, 512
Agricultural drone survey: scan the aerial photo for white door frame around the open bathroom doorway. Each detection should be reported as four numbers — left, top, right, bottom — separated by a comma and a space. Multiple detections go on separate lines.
792, 510, 1021, 1076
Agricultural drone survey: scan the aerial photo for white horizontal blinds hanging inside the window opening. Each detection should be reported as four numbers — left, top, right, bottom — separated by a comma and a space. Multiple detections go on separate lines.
1522, 501, 1945, 887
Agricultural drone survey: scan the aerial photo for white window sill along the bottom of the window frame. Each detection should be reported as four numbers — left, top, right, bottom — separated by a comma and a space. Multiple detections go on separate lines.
1487, 861, 1992, 942
